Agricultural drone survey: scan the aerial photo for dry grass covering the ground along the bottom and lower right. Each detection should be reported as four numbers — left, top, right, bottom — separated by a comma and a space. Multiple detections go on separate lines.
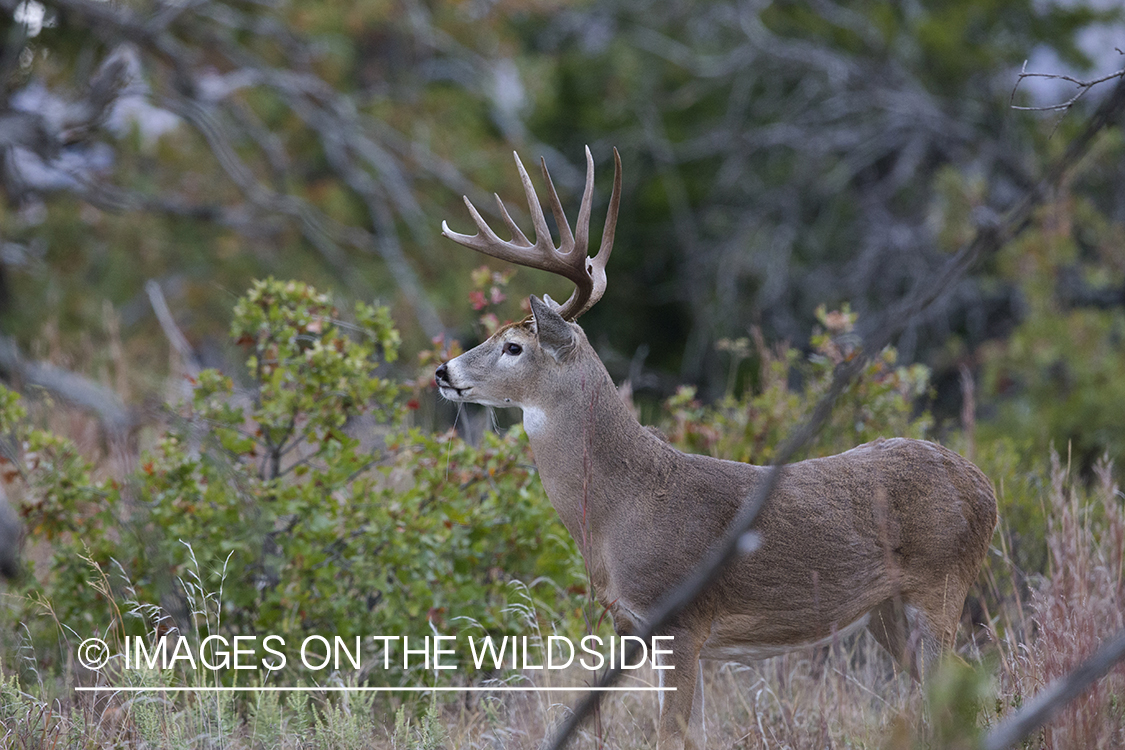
0, 461, 1125, 750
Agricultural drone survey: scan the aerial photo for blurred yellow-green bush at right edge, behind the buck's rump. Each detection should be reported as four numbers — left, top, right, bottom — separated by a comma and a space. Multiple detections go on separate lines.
979, 191, 1125, 477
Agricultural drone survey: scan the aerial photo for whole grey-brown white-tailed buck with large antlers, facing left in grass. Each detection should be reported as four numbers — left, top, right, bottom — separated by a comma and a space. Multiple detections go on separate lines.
437, 148, 996, 747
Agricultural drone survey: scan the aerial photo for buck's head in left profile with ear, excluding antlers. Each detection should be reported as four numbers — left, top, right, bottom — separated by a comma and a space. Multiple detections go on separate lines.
434, 297, 588, 409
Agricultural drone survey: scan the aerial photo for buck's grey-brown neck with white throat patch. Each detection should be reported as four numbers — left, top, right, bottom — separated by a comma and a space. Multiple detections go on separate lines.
523, 354, 672, 553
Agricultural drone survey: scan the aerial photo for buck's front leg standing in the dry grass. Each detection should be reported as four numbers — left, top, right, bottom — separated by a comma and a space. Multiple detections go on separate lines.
657, 630, 705, 750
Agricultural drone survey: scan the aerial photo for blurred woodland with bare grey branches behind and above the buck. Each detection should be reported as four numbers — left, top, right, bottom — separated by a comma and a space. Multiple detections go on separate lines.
0, 0, 1125, 440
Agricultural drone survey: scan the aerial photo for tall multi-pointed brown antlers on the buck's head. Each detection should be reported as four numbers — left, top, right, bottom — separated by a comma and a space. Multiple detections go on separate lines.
441, 146, 621, 320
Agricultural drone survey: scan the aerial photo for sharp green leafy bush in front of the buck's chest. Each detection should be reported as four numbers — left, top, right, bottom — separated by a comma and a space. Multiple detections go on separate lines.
8, 280, 581, 683
